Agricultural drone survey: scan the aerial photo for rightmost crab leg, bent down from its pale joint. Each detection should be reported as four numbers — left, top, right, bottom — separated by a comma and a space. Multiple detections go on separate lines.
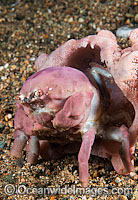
102, 125, 134, 174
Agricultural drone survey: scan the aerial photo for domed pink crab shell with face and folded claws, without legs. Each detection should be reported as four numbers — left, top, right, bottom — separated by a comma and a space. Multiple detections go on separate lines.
15, 67, 99, 138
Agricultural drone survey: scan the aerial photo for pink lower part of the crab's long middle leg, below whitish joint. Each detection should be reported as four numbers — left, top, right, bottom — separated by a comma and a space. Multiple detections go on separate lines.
78, 128, 96, 187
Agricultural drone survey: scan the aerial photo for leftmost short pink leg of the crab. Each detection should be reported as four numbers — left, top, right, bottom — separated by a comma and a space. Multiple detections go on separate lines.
11, 130, 28, 157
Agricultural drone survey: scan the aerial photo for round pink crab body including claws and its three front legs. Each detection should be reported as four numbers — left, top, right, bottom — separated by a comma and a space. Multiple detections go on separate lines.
11, 67, 100, 186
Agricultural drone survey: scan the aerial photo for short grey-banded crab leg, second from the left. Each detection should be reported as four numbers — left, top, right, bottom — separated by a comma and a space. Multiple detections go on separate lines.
27, 136, 40, 164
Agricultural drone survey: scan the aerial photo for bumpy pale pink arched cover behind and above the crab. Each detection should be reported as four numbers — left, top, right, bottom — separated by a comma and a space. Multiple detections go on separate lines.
35, 29, 138, 149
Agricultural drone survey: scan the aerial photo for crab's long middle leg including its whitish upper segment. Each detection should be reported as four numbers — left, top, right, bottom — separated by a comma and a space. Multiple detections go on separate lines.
78, 89, 101, 187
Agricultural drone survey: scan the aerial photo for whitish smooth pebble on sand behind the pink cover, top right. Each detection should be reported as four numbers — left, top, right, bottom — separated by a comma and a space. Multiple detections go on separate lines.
116, 26, 134, 38
